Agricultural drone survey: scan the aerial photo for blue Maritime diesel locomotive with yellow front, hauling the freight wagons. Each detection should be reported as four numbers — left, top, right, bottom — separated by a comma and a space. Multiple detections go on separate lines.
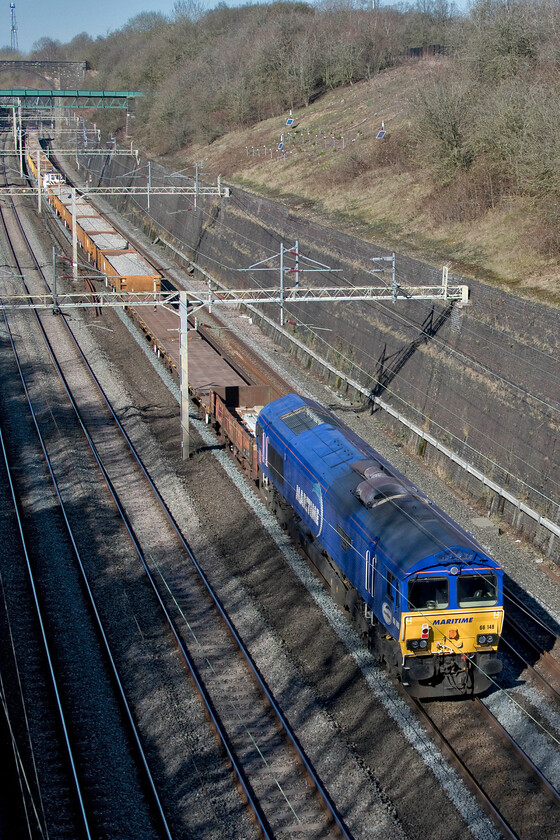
256, 394, 503, 697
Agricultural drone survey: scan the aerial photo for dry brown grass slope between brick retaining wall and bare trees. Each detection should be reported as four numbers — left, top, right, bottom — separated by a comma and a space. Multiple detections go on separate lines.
174, 58, 560, 305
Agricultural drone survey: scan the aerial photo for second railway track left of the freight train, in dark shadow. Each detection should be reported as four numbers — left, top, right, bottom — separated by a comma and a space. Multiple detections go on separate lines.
2, 158, 170, 837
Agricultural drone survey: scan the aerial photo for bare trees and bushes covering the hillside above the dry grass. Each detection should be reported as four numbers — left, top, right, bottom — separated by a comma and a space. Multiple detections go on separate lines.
2, 0, 560, 250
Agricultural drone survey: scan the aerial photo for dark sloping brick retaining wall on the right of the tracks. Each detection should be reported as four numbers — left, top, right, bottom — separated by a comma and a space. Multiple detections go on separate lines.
77, 157, 560, 564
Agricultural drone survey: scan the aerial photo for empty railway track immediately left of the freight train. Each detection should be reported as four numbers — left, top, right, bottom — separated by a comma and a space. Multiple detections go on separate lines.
1, 131, 350, 838
